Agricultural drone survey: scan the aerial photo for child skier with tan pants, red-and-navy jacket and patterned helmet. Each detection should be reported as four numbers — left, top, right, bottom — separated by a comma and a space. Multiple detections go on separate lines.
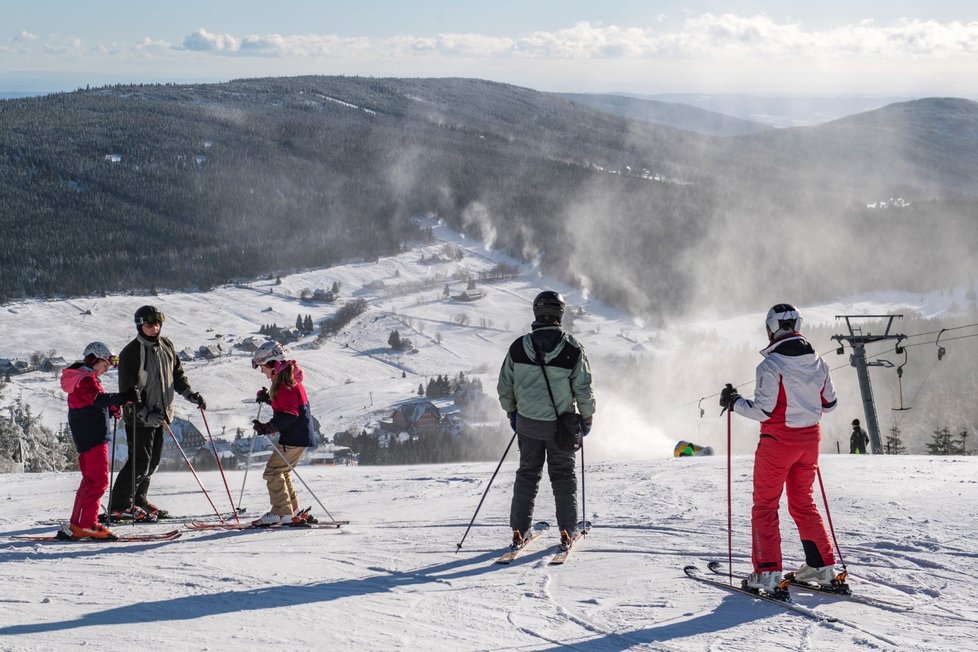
251, 341, 316, 527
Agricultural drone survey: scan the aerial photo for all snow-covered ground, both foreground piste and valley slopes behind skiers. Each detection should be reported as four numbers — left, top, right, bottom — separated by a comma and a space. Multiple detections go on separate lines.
0, 218, 978, 651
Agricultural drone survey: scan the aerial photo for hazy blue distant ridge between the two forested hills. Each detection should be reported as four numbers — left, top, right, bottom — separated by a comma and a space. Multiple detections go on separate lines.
559, 93, 771, 136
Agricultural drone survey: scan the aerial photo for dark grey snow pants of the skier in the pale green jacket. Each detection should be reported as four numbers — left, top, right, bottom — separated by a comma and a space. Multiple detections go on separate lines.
509, 435, 577, 532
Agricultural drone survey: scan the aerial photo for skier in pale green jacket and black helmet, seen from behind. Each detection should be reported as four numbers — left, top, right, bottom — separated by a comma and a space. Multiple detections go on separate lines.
496, 290, 595, 549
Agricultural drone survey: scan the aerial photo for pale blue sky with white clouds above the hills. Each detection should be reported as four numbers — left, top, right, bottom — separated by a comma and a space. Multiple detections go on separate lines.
0, 0, 978, 98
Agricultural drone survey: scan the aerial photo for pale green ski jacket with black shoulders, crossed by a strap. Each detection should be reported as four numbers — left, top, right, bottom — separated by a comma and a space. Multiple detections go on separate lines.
496, 326, 596, 421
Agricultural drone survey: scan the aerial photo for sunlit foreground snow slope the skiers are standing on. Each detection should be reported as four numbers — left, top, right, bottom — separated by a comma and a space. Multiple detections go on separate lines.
0, 454, 978, 652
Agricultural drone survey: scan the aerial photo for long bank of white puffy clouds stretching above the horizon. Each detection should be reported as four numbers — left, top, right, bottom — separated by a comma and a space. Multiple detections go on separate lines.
172, 14, 978, 60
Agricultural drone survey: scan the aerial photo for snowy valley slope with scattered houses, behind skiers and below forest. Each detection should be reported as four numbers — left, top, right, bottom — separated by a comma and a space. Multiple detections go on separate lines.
0, 216, 964, 459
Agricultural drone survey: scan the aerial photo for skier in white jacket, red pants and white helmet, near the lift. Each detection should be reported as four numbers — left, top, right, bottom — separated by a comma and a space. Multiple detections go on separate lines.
720, 303, 836, 594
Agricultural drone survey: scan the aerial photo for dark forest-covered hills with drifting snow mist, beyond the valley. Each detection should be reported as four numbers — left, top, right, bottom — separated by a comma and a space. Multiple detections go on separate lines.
0, 77, 978, 316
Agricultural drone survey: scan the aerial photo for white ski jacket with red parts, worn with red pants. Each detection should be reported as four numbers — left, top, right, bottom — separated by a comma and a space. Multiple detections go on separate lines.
733, 333, 837, 439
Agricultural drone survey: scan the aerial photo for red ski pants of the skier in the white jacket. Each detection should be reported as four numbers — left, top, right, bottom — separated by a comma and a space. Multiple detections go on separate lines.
751, 434, 835, 572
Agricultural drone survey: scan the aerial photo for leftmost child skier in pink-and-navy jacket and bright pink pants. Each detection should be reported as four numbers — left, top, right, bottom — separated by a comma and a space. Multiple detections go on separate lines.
59, 342, 137, 539
